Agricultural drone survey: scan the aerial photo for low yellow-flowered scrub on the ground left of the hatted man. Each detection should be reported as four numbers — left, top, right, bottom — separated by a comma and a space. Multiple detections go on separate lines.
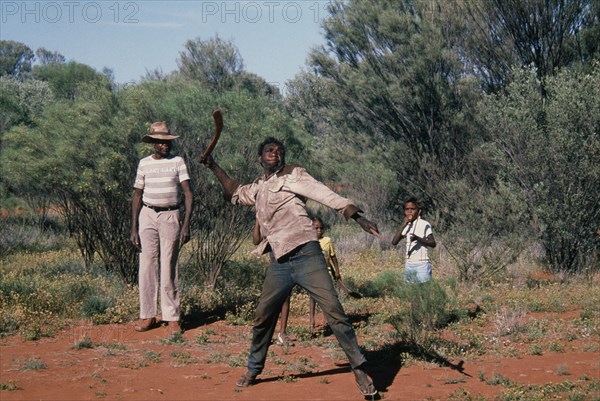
0, 250, 137, 339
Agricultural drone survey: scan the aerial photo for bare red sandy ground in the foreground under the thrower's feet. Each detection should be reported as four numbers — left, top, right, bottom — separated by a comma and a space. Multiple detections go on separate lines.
0, 316, 600, 401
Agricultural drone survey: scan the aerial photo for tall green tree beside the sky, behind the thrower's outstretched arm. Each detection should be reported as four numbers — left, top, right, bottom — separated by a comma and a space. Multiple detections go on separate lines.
293, 0, 478, 214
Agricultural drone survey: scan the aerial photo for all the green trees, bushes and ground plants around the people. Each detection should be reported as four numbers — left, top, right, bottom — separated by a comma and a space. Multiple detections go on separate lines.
0, 0, 600, 401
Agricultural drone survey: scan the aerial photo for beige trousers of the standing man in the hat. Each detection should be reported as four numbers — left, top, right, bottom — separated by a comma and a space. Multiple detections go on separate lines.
139, 206, 180, 322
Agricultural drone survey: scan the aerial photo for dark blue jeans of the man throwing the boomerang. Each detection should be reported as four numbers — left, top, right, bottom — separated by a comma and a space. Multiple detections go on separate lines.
248, 241, 366, 375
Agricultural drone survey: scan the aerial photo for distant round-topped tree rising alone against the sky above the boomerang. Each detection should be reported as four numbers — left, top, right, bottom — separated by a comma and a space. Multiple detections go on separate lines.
177, 36, 244, 91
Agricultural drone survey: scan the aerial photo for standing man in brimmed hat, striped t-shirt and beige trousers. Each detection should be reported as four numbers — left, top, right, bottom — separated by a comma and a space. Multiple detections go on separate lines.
130, 121, 192, 333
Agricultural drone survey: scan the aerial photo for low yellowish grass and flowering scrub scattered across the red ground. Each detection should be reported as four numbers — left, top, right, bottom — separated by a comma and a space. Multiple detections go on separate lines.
0, 234, 600, 400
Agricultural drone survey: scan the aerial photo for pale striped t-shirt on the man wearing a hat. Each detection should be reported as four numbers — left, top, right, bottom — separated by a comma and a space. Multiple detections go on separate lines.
133, 156, 190, 207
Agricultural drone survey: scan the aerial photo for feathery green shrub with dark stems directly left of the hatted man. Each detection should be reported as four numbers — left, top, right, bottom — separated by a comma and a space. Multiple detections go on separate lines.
1, 82, 137, 283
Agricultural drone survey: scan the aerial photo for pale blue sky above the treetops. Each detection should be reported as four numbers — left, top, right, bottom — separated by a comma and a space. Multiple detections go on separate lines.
0, 0, 329, 93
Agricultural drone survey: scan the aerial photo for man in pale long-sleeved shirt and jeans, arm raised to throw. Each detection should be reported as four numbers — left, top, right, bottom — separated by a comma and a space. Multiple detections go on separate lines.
200, 137, 378, 396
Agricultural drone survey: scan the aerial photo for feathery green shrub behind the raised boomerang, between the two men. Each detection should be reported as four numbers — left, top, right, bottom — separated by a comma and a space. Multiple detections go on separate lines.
115, 78, 304, 289
